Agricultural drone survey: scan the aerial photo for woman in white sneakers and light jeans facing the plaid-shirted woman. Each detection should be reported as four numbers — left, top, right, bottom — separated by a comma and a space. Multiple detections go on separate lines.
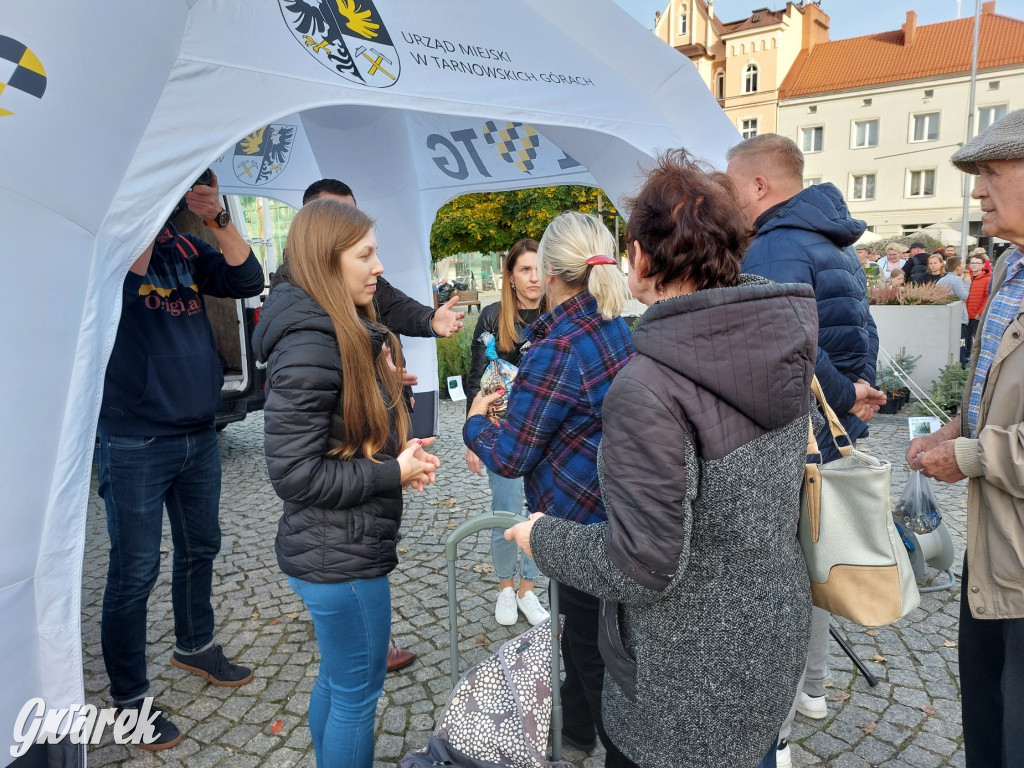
466, 238, 548, 626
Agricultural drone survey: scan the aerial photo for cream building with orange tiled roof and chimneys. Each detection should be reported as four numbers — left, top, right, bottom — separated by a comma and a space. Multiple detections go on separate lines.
777, 2, 1024, 236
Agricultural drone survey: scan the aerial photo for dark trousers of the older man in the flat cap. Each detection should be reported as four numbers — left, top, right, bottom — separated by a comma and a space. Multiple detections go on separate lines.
957, 557, 1024, 768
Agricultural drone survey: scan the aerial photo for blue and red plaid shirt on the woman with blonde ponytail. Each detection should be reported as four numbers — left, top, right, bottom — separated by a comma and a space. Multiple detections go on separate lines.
462, 291, 633, 524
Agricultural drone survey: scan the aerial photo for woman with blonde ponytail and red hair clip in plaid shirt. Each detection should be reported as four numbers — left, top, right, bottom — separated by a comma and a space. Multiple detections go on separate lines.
462, 212, 633, 766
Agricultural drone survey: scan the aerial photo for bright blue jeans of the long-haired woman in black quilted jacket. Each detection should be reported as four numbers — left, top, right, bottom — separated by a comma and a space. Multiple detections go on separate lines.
288, 577, 391, 768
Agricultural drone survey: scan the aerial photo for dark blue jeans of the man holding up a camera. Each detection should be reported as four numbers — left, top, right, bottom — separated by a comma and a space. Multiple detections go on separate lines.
98, 426, 220, 703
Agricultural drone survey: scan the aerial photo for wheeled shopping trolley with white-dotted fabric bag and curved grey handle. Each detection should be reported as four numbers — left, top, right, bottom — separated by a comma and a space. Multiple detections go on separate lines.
400, 512, 573, 768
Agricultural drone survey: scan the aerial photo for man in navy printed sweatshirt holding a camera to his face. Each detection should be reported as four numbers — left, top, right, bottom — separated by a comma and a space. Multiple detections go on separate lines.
98, 169, 263, 751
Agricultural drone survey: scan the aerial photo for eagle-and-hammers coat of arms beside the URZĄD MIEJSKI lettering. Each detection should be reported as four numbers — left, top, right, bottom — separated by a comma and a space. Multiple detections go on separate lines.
278, 0, 401, 88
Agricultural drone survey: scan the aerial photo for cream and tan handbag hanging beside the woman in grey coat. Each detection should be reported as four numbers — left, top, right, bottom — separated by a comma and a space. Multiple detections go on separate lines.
800, 377, 921, 627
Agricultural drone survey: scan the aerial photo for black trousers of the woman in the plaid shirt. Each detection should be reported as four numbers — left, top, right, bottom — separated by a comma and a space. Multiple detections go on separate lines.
558, 584, 636, 768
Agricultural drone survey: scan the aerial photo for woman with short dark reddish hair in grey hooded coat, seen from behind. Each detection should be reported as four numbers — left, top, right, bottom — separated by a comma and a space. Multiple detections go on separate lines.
509, 151, 817, 768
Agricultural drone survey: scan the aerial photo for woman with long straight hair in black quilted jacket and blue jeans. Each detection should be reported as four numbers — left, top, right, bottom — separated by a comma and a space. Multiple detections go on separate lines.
253, 200, 440, 768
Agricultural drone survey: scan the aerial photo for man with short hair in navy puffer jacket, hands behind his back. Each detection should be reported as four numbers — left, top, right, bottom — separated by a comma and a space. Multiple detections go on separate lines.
726, 133, 886, 766
